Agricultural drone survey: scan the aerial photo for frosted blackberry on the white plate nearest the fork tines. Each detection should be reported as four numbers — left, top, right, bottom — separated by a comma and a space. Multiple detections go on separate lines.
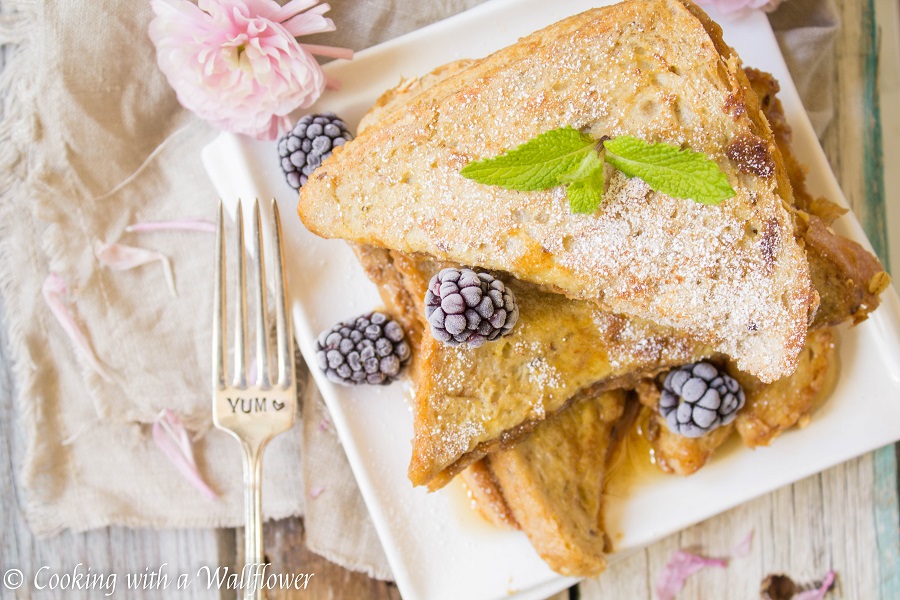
316, 312, 410, 385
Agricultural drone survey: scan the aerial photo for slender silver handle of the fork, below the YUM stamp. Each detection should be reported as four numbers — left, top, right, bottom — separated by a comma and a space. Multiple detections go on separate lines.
241, 440, 268, 600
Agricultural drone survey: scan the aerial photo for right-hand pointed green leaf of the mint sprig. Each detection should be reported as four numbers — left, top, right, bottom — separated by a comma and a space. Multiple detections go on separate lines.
603, 135, 735, 205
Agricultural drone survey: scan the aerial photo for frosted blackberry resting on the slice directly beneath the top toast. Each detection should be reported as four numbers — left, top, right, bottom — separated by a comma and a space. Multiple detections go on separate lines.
425, 269, 519, 348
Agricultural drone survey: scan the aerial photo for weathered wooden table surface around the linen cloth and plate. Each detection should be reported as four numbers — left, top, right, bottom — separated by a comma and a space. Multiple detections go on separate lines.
0, 0, 900, 600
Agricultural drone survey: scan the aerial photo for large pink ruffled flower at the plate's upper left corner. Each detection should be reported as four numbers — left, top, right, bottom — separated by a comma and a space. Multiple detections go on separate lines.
150, 0, 352, 139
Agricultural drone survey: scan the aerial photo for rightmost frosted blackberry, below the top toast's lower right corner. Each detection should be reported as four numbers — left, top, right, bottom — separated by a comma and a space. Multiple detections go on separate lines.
659, 361, 745, 438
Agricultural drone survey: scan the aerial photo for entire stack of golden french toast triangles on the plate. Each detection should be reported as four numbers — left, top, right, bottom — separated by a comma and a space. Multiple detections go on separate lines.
299, 0, 889, 576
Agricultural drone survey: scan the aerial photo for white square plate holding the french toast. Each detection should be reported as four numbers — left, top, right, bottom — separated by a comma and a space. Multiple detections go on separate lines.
203, 0, 900, 600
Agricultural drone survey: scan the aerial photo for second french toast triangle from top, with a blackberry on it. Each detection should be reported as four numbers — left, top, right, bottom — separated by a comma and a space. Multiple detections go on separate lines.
357, 247, 711, 490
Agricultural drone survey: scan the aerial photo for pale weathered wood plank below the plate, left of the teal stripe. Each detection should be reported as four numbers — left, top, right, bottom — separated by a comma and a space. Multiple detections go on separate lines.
580, 462, 879, 600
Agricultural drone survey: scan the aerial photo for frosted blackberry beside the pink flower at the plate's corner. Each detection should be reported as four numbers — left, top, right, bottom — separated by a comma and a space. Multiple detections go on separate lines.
278, 112, 353, 190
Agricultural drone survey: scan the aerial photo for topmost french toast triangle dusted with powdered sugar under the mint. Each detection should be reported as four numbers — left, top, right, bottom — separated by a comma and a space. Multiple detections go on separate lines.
298, 0, 818, 384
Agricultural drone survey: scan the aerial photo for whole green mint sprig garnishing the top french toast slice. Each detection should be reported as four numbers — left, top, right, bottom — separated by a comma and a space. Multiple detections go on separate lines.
460, 127, 735, 214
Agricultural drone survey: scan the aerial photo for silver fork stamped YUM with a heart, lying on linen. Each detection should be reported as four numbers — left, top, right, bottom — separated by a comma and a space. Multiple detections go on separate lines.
212, 200, 297, 598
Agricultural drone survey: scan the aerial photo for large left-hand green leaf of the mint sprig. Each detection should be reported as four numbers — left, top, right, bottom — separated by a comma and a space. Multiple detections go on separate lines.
460, 127, 596, 192
